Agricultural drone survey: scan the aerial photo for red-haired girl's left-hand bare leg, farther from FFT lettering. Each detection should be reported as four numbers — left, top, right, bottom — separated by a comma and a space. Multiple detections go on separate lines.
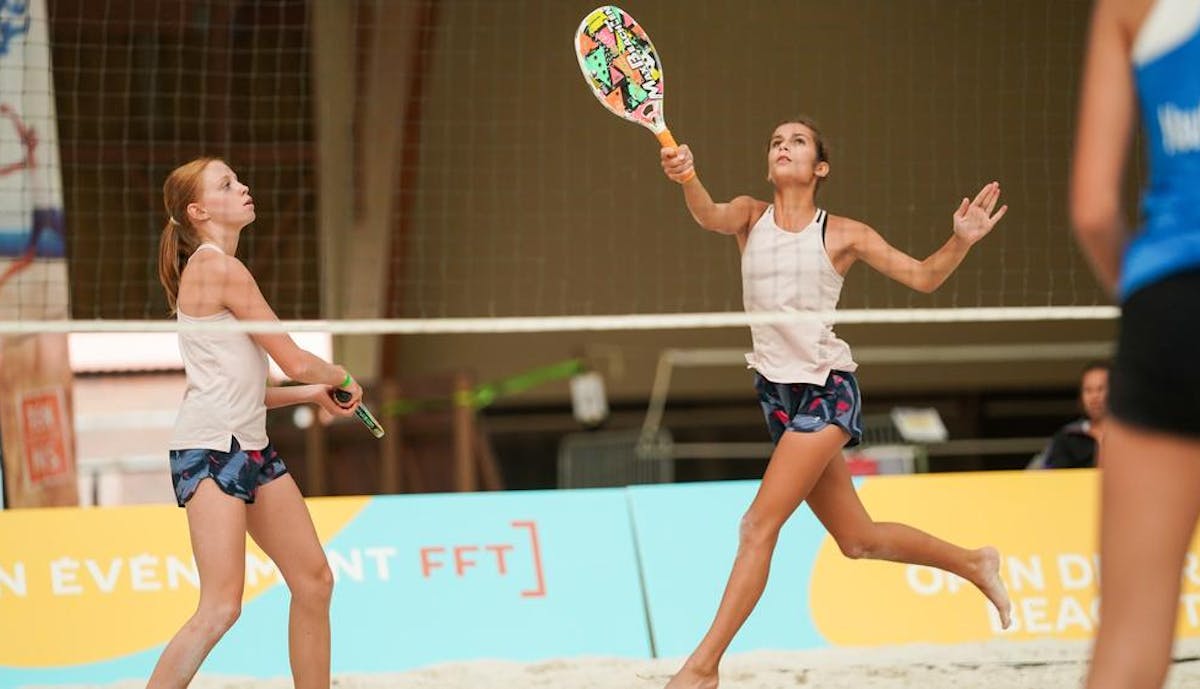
146, 480, 246, 689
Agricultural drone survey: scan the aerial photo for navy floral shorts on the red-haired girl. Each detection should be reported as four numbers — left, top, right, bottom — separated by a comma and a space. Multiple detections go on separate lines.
170, 438, 288, 507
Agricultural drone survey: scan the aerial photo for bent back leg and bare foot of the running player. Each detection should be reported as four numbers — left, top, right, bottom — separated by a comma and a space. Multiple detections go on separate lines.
808, 453, 1012, 628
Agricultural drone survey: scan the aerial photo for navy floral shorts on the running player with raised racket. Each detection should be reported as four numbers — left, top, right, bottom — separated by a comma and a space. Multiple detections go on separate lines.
754, 371, 863, 448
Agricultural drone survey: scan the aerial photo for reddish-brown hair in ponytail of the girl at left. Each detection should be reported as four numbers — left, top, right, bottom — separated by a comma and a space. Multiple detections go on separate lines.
158, 157, 217, 313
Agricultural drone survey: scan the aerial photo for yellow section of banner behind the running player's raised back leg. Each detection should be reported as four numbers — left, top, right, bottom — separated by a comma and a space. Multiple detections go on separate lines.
810, 469, 1200, 646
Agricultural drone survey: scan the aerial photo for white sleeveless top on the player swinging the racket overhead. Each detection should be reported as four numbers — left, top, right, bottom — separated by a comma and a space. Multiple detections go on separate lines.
742, 205, 858, 385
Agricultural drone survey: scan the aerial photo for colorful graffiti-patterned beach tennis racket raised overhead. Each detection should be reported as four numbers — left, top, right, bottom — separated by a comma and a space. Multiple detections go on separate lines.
575, 5, 690, 179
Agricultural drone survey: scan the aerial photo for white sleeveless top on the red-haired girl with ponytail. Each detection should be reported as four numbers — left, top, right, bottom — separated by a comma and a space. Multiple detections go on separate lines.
169, 244, 268, 453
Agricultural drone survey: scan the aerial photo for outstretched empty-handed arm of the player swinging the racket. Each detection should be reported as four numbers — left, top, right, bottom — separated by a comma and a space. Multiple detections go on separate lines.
844, 182, 1008, 293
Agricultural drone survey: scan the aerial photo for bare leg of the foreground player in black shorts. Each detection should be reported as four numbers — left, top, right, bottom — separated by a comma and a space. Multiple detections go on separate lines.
1087, 419, 1200, 689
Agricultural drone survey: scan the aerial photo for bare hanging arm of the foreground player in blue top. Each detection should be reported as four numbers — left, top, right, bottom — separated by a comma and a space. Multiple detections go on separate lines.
1070, 0, 1135, 294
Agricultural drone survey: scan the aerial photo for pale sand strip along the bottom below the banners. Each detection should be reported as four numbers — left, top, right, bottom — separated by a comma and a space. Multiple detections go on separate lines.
79, 641, 1200, 689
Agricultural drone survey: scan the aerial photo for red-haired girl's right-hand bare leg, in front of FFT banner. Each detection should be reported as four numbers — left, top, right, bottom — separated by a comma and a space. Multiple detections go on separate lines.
246, 474, 334, 689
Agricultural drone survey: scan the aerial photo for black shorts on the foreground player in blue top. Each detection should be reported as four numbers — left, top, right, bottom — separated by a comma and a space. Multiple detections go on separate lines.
1109, 270, 1200, 438
